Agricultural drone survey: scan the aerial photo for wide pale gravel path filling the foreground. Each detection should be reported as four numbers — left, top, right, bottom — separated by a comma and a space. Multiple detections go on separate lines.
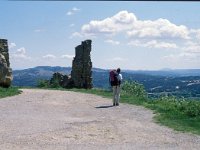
0, 89, 200, 150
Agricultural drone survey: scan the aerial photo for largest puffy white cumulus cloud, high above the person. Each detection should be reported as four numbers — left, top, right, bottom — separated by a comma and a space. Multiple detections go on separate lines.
77, 10, 190, 39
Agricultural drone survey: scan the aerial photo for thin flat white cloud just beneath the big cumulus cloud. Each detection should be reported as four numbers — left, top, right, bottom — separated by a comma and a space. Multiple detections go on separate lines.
128, 40, 178, 49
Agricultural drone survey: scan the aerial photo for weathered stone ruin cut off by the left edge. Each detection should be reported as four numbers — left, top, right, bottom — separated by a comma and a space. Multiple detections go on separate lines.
0, 39, 12, 87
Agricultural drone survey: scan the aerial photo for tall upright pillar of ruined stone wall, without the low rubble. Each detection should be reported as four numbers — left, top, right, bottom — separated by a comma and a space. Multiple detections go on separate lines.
71, 40, 92, 89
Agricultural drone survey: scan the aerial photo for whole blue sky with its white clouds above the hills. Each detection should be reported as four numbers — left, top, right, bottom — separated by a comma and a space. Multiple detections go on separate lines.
0, 1, 200, 70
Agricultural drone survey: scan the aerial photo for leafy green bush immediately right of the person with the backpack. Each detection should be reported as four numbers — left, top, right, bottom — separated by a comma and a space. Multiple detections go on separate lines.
121, 81, 147, 98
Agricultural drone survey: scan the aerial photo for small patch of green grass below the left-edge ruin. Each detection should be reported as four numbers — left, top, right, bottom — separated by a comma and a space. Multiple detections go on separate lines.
0, 87, 21, 98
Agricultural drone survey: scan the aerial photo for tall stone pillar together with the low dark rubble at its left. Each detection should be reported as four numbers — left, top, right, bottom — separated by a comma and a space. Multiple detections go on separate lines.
50, 40, 92, 89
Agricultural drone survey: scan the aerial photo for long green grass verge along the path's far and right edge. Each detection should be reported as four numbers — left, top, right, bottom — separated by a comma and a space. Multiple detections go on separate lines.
66, 89, 200, 135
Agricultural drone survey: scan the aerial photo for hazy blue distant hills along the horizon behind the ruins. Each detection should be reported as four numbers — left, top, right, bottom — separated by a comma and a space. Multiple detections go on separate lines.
12, 66, 200, 97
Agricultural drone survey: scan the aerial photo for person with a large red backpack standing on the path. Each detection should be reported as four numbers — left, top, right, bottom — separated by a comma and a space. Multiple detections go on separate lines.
109, 68, 122, 106
